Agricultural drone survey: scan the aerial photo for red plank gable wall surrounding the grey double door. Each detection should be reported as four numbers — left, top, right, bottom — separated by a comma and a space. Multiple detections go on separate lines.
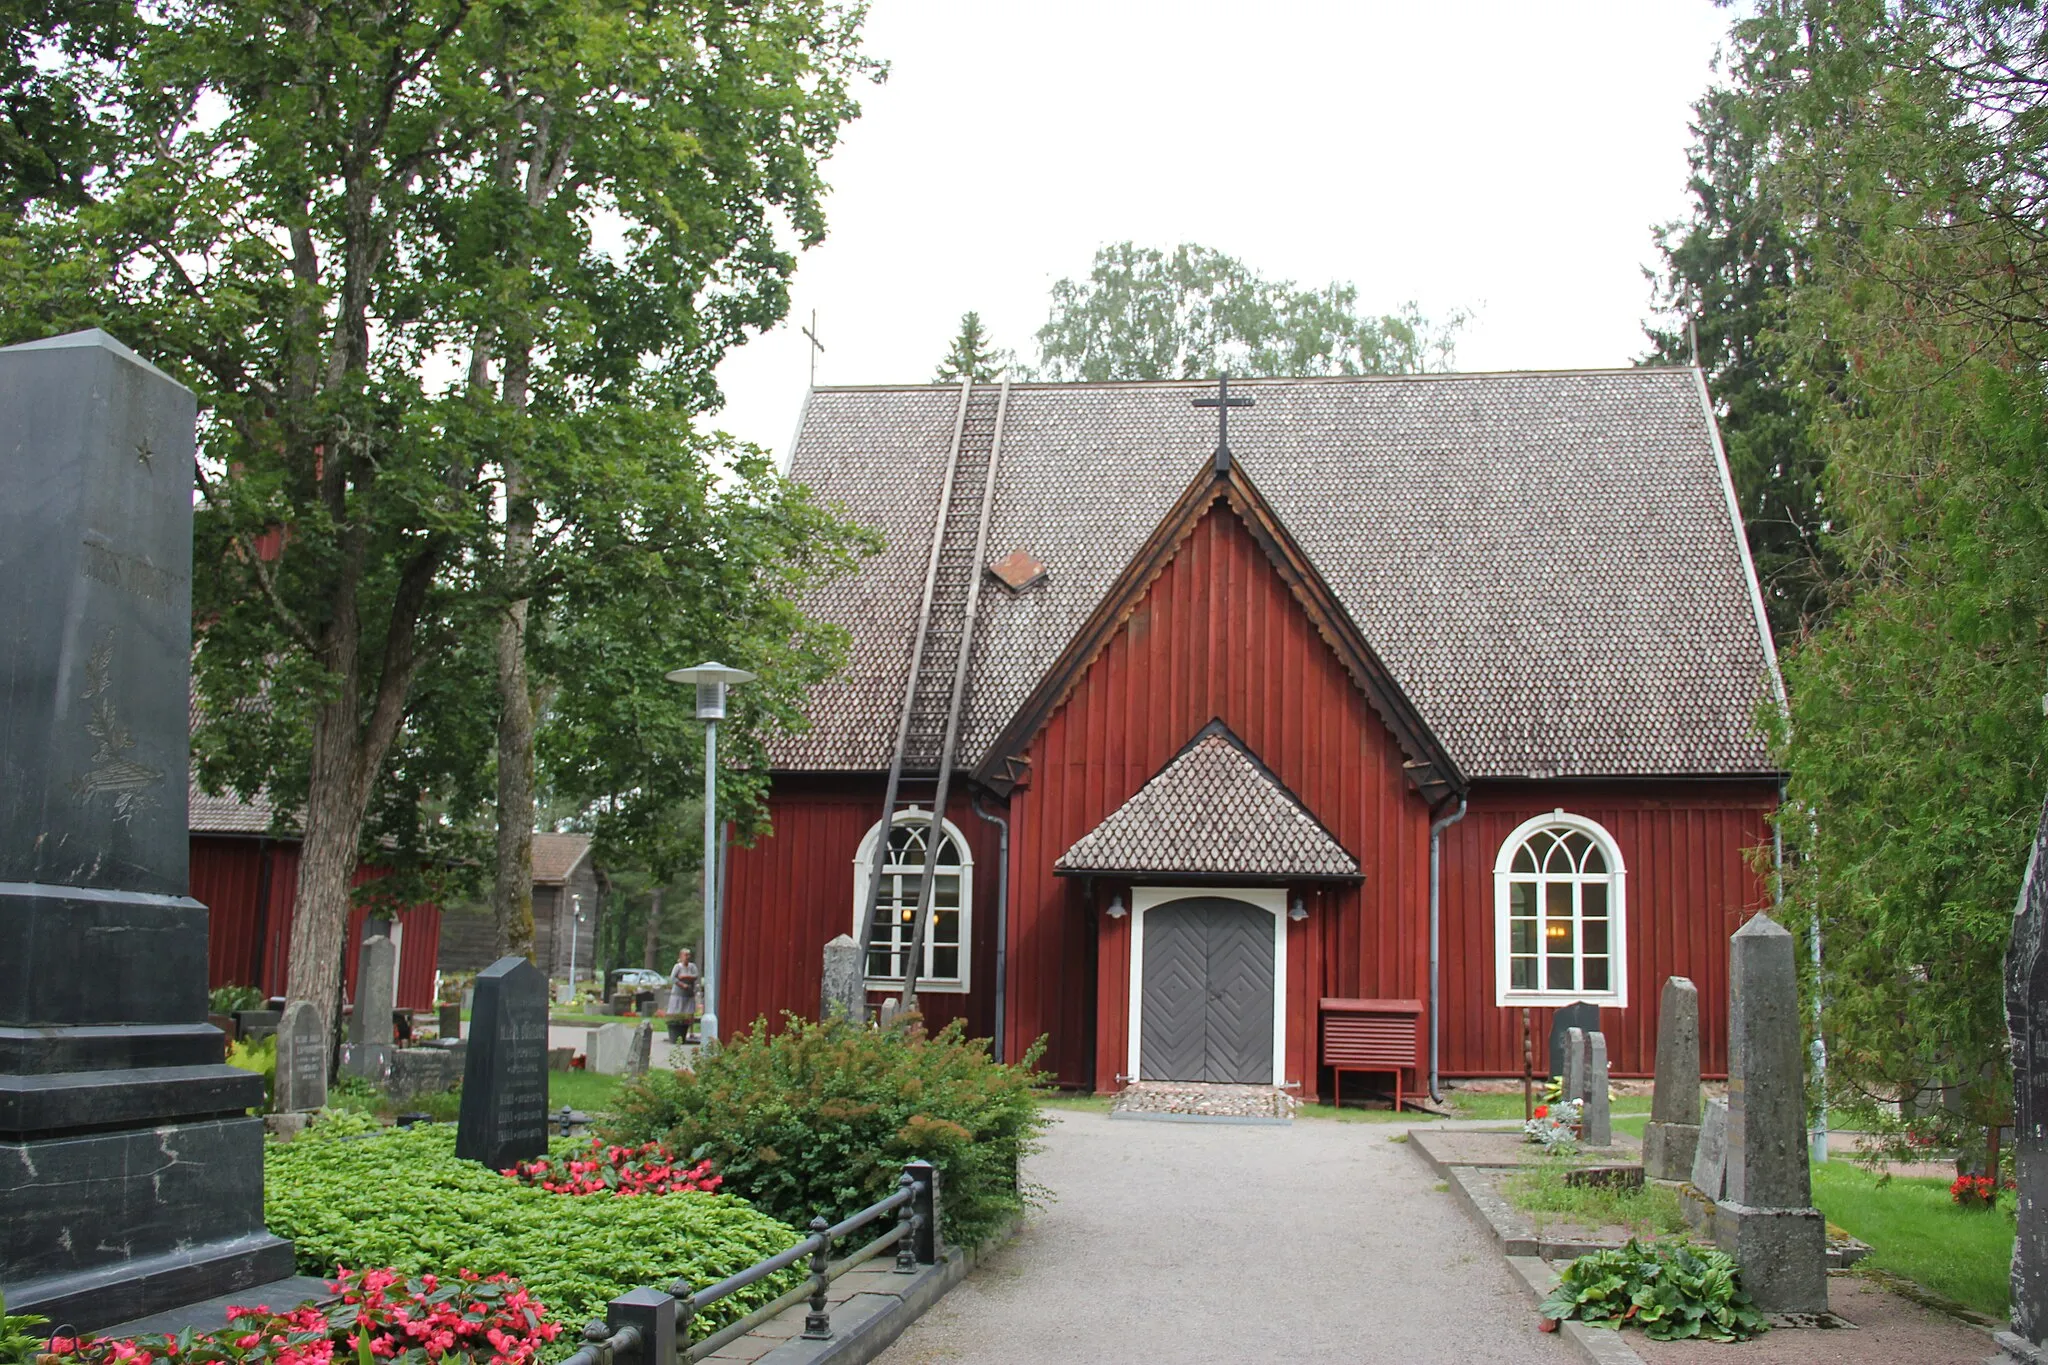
1008, 505, 1430, 1095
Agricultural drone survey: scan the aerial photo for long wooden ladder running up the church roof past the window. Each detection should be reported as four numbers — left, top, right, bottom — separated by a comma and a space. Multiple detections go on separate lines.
858, 379, 1010, 1009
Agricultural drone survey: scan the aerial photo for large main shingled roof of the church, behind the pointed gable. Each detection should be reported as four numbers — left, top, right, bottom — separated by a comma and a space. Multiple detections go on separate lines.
772, 368, 1778, 778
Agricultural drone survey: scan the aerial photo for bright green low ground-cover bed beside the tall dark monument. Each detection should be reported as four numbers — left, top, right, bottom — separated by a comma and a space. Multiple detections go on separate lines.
264, 1121, 801, 1336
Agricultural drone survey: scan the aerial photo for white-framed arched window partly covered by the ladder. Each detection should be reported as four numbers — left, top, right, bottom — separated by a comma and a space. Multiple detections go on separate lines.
854, 808, 975, 990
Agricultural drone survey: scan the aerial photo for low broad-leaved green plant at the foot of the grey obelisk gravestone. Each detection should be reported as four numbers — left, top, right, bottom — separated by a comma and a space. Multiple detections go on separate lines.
1538, 1238, 1769, 1340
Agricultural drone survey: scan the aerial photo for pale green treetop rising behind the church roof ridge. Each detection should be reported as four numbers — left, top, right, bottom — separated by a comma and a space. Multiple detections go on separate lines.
1038, 241, 1464, 381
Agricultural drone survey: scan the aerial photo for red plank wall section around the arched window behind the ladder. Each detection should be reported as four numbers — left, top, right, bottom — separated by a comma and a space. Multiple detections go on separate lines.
719, 776, 1003, 1042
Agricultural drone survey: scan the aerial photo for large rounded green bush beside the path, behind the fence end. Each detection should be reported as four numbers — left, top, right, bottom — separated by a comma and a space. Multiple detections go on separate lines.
602, 1015, 1047, 1246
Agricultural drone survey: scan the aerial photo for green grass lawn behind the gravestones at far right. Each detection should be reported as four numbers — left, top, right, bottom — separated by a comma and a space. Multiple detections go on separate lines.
1812, 1160, 2013, 1318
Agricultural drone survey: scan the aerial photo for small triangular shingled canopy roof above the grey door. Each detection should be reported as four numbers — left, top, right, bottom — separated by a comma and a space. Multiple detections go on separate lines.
1053, 720, 1358, 880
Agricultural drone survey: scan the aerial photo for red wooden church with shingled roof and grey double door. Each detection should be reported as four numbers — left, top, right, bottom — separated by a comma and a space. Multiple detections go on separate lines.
721, 368, 1778, 1095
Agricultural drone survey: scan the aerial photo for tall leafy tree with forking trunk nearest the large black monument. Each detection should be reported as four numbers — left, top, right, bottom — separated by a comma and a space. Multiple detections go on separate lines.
0, 0, 868, 1035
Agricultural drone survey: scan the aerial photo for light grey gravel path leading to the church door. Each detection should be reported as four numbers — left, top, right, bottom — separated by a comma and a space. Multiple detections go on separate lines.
881, 1111, 1575, 1365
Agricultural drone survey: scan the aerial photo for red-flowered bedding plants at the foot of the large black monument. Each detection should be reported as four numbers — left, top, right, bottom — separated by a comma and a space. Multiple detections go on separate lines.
43, 1271, 561, 1365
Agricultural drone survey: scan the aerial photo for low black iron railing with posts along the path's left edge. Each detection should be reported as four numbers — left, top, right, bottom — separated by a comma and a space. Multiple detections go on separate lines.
561, 1160, 940, 1365
